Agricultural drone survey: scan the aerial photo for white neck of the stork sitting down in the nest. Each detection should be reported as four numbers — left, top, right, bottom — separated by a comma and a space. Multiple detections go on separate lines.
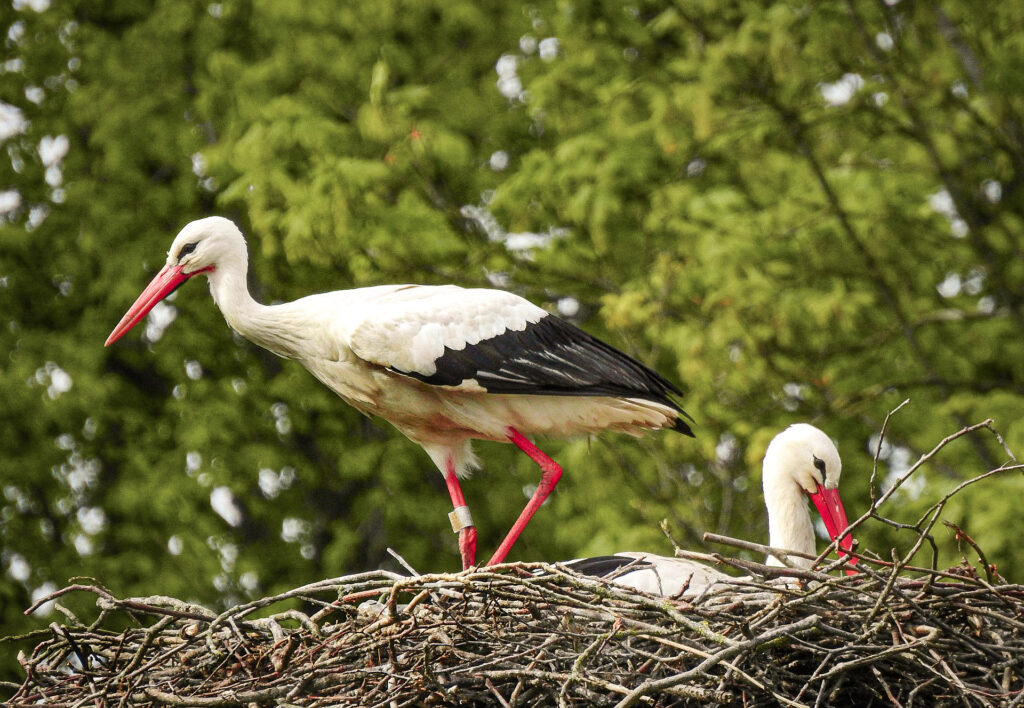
763, 444, 816, 568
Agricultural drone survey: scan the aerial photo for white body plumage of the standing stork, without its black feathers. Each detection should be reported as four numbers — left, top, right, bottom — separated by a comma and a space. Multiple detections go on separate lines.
246, 285, 678, 447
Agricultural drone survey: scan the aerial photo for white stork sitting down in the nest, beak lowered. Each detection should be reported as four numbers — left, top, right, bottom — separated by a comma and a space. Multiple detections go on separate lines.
566, 423, 857, 597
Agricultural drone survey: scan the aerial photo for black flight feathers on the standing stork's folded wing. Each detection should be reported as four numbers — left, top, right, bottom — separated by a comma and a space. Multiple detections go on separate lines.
394, 315, 693, 435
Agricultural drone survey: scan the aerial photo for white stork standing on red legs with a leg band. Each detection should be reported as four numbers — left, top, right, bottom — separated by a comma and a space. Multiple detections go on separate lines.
106, 216, 693, 568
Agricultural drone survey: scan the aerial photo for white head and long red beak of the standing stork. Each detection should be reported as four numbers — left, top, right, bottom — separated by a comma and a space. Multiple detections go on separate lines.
105, 216, 249, 345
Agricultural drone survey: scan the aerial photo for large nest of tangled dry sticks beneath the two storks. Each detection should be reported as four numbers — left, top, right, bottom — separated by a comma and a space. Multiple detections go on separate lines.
8, 421, 1024, 706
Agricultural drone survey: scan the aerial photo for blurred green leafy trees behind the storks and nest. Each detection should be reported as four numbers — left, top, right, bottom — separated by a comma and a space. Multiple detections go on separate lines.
0, 0, 1024, 688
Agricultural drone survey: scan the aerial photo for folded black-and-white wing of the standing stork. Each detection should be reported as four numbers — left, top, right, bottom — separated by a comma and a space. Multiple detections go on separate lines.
350, 286, 692, 434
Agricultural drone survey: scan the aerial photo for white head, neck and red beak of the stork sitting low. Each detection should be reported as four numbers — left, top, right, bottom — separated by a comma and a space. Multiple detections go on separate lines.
762, 423, 853, 569
